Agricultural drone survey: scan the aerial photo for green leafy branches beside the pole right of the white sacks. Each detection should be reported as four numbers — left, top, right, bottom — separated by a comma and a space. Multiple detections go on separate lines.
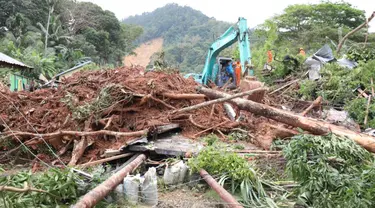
188, 142, 276, 207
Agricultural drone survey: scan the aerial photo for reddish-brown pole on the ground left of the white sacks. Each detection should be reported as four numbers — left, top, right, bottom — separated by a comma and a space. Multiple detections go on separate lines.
73, 154, 146, 208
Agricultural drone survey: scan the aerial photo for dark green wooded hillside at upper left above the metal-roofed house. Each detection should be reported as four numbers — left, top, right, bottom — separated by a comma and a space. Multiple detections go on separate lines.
0, 0, 142, 76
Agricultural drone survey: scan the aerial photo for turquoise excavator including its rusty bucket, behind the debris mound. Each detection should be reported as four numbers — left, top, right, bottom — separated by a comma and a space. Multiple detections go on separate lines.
185, 17, 265, 102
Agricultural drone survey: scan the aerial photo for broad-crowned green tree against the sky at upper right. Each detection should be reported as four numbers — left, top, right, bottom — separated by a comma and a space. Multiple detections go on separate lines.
273, 2, 365, 50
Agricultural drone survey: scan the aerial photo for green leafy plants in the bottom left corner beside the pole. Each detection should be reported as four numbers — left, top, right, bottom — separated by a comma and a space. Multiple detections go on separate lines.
0, 166, 120, 208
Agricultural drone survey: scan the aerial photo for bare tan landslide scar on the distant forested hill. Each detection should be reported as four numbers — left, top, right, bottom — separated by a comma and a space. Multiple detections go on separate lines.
124, 38, 163, 67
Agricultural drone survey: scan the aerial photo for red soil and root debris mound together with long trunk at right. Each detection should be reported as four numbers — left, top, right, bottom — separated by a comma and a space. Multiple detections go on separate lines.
0, 67, 375, 169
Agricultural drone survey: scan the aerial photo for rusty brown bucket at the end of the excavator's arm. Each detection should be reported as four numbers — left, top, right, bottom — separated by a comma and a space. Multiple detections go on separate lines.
240, 77, 266, 103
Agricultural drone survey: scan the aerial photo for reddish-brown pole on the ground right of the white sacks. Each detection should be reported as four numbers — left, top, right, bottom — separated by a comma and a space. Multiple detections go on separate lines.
199, 169, 243, 208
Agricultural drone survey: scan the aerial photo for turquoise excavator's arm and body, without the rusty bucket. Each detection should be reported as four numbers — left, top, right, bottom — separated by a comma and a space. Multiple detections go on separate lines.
185, 17, 254, 87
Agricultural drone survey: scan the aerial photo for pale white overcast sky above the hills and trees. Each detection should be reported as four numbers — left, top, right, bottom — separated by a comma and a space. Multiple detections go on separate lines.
80, 0, 375, 32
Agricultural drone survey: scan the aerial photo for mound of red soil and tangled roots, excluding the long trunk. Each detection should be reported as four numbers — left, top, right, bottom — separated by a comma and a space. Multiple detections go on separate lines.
0, 67, 262, 165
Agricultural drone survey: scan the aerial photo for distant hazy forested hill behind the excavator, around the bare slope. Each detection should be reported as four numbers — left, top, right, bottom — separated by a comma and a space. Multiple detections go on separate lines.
123, 4, 236, 72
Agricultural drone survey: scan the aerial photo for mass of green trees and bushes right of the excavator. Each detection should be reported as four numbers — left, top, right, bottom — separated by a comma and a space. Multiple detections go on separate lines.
251, 2, 375, 82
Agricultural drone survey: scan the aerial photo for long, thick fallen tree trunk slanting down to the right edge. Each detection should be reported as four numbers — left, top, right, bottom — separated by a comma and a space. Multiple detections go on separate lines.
200, 88, 375, 152
